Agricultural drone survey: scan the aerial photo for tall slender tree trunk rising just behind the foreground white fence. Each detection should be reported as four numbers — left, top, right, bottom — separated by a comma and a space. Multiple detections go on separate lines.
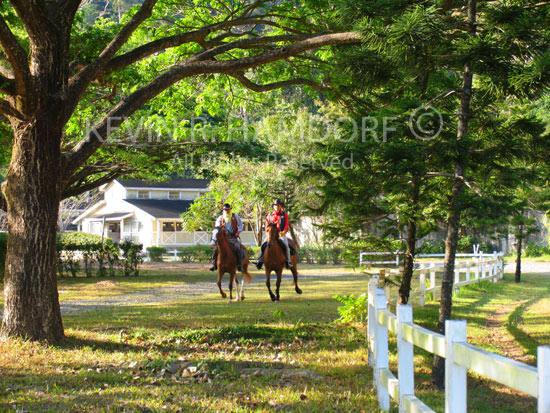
432, 0, 477, 389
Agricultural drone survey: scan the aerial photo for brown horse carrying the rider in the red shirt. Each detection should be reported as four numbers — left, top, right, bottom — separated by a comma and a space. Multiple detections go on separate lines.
264, 223, 302, 302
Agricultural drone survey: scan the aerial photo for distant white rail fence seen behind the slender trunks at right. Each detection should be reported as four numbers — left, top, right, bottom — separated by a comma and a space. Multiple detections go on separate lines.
360, 252, 504, 306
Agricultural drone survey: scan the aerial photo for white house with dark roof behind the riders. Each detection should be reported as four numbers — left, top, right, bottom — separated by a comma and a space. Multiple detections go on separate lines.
73, 178, 255, 249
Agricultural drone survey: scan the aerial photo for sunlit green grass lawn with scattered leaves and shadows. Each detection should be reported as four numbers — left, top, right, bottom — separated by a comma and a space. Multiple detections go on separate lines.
0, 266, 550, 412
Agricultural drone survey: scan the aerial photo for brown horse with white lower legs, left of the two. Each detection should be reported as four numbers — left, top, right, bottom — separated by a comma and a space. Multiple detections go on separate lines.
216, 225, 252, 302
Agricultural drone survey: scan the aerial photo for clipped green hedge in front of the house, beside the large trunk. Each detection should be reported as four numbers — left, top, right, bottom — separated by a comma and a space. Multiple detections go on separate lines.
57, 232, 143, 277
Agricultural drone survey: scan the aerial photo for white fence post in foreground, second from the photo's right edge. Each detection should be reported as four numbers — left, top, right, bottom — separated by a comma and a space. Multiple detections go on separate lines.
445, 320, 466, 413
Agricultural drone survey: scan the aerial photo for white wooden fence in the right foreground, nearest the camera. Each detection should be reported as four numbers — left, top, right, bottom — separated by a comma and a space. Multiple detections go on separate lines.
367, 279, 550, 413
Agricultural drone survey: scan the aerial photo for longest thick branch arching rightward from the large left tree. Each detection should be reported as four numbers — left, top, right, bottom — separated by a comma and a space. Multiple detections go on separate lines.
64, 32, 362, 179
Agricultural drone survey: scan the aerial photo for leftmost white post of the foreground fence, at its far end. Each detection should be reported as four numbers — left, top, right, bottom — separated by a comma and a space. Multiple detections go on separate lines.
374, 288, 390, 410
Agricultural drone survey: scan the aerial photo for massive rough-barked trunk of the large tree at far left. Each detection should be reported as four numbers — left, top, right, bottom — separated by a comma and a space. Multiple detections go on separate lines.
1, 25, 70, 342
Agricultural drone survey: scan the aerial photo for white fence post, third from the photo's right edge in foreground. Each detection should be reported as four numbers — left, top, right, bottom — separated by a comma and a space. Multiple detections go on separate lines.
397, 304, 414, 413
